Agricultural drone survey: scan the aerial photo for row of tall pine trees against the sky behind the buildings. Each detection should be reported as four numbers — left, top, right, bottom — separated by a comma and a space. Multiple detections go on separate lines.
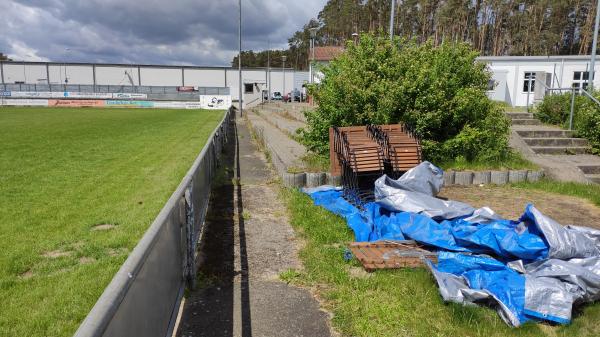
232, 0, 596, 69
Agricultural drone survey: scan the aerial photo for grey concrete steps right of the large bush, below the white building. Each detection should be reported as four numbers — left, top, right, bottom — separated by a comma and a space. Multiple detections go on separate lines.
506, 112, 589, 155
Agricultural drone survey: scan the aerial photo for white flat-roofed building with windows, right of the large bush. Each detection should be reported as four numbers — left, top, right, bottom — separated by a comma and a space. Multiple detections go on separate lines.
478, 55, 600, 106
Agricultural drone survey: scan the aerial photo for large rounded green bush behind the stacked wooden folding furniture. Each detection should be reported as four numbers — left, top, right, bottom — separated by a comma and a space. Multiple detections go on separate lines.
301, 34, 510, 162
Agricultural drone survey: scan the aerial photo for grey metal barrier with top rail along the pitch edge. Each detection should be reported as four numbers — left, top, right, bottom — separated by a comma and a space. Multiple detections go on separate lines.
75, 109, 234, 337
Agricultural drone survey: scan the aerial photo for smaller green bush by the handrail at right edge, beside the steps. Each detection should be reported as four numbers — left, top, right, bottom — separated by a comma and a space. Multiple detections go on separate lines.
534, 91, 600, 154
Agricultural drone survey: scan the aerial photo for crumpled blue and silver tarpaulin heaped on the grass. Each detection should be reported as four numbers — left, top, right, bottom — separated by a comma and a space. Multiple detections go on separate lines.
305, 162, 600, 326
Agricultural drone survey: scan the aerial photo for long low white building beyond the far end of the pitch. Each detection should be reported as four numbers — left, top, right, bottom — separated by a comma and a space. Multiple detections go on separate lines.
0, 61, 309, 104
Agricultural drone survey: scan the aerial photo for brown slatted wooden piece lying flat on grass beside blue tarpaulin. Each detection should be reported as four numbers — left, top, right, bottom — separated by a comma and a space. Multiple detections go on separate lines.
350, 241, 437, 272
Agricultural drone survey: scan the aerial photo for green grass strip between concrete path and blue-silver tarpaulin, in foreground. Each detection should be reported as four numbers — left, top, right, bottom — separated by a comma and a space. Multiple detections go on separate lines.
281, 188, 600, 337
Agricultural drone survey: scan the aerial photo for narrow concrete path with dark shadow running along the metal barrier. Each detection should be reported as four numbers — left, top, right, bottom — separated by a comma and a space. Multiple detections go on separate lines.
177, 115, 331, 337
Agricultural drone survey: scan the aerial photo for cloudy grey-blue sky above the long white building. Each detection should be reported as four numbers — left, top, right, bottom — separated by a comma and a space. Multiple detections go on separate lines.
0, 0, 326, 66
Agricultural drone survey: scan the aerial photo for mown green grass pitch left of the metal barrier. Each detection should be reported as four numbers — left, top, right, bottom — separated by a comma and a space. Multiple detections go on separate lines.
0, 108, 223, 336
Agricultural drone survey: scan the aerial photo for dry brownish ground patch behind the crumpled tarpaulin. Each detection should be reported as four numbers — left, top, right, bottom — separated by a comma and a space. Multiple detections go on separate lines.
440, 186, 600, 229
